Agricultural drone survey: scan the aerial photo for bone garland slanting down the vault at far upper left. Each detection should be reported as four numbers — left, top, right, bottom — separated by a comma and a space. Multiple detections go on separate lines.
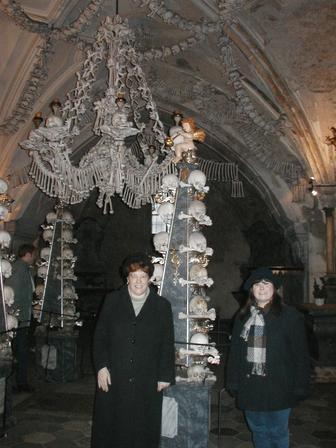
0, 39, 51, 134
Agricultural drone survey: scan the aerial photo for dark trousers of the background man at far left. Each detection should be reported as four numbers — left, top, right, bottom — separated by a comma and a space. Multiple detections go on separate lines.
13, 327, 29, 386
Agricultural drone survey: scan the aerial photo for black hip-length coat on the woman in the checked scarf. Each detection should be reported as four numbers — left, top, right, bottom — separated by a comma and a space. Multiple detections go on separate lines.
226, 305, 310, 411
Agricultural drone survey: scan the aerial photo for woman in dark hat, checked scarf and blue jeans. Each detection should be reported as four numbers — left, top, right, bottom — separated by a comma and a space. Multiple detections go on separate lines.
226, 268, 310, 448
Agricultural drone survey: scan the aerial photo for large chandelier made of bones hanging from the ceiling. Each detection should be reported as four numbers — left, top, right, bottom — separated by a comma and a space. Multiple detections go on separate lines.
21, 16, 175, 213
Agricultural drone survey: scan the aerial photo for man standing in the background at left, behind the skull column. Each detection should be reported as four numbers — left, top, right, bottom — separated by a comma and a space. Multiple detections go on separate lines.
6, 244, 36, 392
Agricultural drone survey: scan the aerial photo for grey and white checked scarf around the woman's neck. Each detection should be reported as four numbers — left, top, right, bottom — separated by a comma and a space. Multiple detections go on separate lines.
240, 305, 266, 376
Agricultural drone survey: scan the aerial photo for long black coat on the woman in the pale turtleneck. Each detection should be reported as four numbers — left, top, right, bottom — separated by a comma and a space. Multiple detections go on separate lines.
92, 287, 175, 448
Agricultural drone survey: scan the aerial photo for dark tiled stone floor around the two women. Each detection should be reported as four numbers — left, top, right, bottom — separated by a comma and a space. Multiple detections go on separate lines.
0, 375, 336, 448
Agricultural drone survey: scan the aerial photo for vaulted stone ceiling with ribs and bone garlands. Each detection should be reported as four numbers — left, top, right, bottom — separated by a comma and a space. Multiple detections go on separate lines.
0, 0, 336, 228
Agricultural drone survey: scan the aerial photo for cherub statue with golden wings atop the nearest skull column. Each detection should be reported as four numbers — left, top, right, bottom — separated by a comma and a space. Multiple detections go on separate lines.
173, 118, 205, 163
